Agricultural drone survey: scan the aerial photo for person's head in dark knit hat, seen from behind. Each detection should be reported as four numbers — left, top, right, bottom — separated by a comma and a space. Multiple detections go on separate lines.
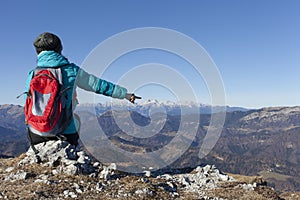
33, 32, 62, 54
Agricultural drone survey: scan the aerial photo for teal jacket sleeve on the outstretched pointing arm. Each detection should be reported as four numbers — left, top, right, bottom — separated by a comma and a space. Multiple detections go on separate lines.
76, 68, 127, 99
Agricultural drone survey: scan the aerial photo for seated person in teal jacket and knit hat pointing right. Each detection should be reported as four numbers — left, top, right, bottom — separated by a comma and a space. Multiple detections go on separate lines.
25, 32, 140, 146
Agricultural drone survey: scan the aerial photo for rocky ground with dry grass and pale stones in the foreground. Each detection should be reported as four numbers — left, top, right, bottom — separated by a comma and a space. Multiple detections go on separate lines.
0, 141, 300, 200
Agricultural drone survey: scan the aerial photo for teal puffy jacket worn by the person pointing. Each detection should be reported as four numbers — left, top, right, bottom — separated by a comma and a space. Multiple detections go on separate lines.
25, 51, 127, 134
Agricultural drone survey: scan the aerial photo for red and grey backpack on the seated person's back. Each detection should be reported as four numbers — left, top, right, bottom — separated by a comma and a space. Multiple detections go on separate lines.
24, 67, 72, 137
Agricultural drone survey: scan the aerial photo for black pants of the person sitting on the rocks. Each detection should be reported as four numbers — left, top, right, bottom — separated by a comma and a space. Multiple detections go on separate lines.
28, 132, 79, 146
